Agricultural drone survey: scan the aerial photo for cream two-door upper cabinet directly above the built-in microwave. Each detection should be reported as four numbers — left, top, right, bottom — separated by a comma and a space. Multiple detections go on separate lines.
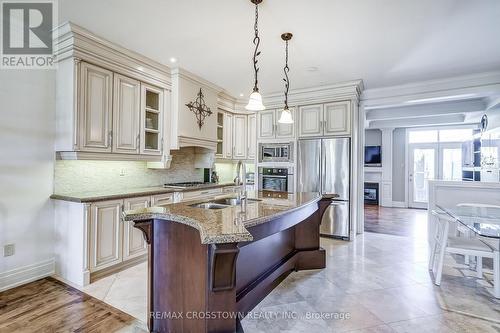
258, 108, 295, 139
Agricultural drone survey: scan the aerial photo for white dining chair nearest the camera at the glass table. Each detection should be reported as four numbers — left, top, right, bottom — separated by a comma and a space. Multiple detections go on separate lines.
429, 210, 500, 298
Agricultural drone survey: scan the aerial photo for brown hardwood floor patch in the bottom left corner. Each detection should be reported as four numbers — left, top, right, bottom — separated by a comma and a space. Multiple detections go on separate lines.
0, 278, 142, 333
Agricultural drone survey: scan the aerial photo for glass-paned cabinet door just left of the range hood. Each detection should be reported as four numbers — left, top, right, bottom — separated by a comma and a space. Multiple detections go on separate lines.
140, 83, 164, 155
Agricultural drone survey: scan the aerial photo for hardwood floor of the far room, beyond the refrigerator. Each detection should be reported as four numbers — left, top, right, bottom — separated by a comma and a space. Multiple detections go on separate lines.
365, 205, 427, 236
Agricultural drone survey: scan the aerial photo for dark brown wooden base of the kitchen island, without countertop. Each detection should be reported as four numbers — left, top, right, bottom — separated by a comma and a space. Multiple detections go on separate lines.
135, 193, 326, 333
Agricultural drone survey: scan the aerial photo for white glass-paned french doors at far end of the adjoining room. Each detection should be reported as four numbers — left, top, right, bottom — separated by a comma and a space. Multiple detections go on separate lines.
408, 143, 462, 208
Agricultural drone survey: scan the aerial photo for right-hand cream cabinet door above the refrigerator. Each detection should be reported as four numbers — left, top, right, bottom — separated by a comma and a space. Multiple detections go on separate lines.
324, 101, 351, 135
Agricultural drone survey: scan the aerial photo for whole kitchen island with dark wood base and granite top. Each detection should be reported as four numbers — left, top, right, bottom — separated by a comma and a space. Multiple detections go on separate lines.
124, 192, 327, 332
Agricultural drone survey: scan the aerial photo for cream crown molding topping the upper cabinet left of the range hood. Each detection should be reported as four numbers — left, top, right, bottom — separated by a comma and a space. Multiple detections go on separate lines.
54, 22, 171, 89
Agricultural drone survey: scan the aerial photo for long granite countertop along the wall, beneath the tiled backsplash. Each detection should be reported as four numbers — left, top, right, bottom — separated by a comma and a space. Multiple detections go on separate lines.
50, 183, 235, 203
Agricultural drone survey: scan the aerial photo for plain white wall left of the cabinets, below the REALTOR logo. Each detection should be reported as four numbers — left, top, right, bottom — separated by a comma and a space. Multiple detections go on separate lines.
0, 70, 55, 290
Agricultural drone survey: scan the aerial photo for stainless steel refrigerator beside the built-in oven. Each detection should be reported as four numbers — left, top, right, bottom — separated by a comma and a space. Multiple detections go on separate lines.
297, 138, 351, 239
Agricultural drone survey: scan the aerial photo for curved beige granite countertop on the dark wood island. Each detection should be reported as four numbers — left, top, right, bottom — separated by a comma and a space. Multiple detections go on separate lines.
124, 191, 321, 244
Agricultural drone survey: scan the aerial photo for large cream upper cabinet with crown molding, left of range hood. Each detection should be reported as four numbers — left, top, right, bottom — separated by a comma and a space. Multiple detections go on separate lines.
55, 23, 171, 162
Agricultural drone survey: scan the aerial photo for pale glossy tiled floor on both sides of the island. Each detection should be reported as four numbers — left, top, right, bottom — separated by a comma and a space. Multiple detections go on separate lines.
85, 208, 500, 333
